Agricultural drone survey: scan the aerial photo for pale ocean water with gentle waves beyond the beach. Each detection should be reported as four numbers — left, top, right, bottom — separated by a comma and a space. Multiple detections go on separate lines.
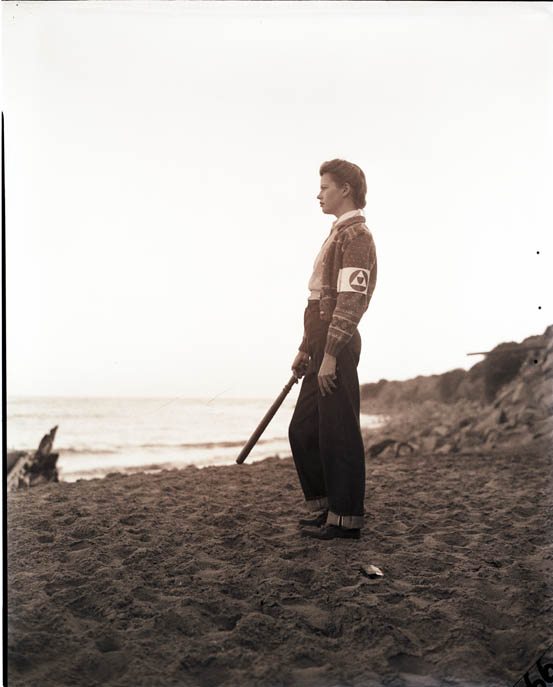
7, 397, 382, 482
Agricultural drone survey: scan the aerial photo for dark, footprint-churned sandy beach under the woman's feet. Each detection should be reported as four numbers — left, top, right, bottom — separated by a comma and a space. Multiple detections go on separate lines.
8, 440, 553, 687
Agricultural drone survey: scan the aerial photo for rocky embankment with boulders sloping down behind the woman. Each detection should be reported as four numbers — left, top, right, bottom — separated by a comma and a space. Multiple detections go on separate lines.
361, 325, 553, 456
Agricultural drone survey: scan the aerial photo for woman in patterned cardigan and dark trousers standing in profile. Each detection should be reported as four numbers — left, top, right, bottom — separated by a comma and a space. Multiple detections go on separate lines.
289, 159, 377, 539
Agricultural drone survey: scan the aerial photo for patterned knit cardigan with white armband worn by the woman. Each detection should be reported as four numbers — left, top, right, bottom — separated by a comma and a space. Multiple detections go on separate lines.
299, 215, 377, 356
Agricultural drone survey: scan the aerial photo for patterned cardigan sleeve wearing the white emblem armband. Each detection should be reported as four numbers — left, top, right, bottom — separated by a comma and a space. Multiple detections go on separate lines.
325, 231, 376, 356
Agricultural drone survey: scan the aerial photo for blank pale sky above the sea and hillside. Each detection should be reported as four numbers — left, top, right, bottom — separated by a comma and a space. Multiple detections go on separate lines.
2, 1, 553, 397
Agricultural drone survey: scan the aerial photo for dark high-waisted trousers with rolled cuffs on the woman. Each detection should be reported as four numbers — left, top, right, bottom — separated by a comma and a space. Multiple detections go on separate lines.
288, 301, 365, 528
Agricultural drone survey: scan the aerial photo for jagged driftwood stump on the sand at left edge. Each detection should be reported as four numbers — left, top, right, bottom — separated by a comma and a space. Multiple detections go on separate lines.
6, 425, 59, 490
